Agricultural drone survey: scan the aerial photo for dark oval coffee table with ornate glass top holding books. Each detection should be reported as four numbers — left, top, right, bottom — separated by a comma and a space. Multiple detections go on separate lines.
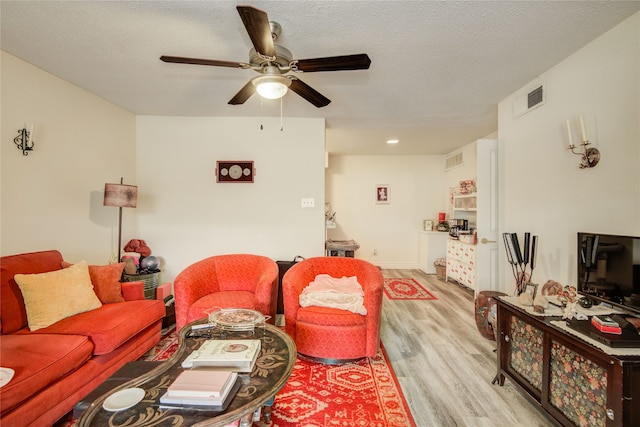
77, 319, 296, 427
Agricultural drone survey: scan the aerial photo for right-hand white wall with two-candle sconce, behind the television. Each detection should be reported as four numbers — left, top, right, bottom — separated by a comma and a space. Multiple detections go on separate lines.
498, 13, 640, 293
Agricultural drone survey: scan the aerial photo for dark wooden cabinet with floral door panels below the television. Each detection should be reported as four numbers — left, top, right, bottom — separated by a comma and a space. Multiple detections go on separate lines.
496, 298, 640, 427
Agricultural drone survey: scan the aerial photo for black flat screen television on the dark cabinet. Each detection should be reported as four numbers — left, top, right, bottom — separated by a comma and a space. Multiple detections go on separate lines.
577, 232, 640, 313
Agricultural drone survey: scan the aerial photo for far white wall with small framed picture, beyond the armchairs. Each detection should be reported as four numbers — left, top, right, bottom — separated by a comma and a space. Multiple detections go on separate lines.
326, 155, 447, 268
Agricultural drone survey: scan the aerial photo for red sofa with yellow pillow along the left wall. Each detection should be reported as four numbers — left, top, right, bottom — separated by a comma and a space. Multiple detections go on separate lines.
0, 250, 166, 427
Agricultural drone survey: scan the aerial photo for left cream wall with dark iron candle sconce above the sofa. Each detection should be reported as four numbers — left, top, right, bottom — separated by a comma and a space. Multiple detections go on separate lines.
0, 52, 136, 264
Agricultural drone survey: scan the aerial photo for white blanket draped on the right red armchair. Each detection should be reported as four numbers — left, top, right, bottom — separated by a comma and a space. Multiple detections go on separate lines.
300, 274, 367, 315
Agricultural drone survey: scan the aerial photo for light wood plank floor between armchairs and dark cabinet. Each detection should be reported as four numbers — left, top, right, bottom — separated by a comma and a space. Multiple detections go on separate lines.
381, 269, 554, 427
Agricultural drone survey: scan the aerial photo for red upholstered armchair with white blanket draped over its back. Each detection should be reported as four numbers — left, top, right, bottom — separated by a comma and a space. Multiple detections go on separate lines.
282, 257, 383, 363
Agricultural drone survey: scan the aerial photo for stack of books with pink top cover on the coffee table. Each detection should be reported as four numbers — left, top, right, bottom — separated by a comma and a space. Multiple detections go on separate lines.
160, 369, 238, 410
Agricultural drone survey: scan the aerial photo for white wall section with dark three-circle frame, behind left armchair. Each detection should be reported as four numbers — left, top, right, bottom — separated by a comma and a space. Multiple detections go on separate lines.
136, 116, 325, 281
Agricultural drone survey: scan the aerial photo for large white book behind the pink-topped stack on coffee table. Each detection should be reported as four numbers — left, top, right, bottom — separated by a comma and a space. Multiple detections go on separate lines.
182, 340, 261, 372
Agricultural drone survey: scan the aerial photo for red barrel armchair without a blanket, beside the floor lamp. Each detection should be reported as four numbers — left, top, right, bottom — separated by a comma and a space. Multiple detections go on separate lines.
173, 254, 278, 330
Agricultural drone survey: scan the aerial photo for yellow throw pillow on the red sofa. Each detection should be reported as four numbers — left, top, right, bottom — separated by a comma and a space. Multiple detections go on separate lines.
14, 261, 102, 331
